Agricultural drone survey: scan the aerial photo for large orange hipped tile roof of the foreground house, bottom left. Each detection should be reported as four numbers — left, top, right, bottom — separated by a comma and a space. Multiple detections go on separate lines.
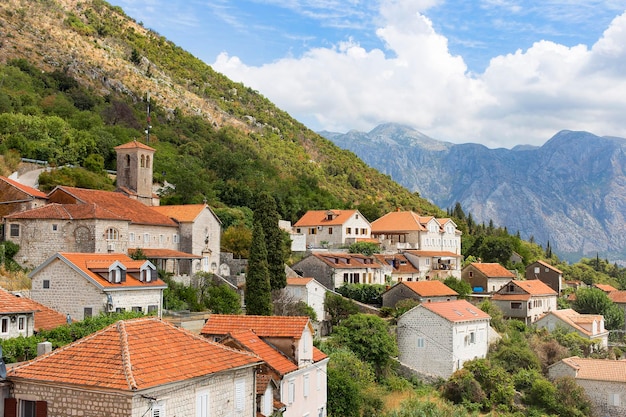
8, 317, 260, 391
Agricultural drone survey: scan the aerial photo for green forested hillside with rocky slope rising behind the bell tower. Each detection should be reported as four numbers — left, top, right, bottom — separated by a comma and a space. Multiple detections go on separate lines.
0, 0, 441, 221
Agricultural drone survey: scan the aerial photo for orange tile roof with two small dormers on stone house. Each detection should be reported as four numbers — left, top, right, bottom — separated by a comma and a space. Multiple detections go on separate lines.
31, 252, 167, 289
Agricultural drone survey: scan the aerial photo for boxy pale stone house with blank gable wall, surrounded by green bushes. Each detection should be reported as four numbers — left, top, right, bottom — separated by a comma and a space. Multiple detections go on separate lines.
397, 300, 491, 379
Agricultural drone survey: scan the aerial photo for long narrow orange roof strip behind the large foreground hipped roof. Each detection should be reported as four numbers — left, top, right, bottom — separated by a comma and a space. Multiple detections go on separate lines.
200, 314, 313, 339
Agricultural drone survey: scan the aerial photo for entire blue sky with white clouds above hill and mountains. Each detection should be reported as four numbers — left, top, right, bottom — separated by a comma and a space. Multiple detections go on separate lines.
109, 0, 626, 148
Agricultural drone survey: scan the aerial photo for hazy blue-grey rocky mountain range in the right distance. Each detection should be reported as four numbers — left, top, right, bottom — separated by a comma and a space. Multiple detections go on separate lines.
320, 124, 626, 263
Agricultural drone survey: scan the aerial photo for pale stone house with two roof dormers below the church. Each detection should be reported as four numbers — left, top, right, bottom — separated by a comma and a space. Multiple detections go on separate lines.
29, 252, 167, 320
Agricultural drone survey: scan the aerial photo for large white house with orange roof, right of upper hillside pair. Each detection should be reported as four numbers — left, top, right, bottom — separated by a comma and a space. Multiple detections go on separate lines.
372, 210, 461, 255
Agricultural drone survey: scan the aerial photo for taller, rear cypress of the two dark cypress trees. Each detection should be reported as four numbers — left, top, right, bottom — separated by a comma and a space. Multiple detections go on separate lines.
254, 192, 287, 290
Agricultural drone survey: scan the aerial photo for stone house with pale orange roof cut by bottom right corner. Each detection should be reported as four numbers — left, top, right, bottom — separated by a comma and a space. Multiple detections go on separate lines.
548, 356, 626, 416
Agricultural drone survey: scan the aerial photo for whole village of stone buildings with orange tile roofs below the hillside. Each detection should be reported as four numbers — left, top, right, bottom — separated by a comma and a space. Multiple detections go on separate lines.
0, 141, 626, 417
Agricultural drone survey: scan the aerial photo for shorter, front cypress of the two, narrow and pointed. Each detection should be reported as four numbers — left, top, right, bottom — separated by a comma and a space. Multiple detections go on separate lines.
244, 222, 272, 316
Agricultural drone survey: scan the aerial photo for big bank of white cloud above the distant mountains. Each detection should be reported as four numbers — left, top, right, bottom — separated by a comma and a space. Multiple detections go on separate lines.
213, 0, 626, 147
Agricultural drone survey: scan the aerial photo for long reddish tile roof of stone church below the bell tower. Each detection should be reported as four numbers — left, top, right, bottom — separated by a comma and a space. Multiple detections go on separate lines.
48, 186, 178, 227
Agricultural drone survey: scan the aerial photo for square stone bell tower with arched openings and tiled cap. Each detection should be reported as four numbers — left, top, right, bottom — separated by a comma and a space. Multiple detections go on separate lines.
115, 140, 158, 206
